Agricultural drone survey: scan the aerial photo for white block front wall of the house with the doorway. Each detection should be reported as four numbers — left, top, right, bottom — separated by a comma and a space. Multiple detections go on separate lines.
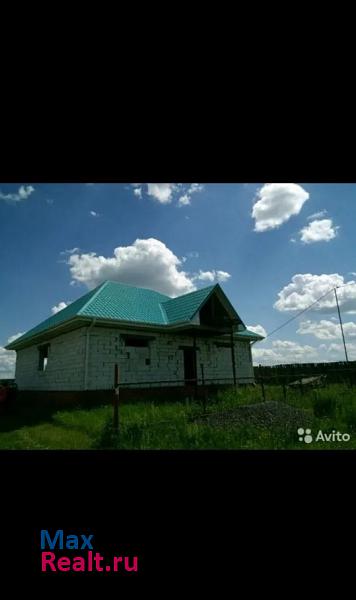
87, 327, 253, 390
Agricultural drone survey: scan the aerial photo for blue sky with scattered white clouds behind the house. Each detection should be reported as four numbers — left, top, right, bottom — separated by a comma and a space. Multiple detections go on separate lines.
0, 182, 356, 378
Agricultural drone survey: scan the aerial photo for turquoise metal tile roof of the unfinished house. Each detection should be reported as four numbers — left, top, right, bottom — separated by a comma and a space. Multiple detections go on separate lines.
7, 281, 260, 350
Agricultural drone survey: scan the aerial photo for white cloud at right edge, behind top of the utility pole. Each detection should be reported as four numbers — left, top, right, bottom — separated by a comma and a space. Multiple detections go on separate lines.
274, 273, 356, 313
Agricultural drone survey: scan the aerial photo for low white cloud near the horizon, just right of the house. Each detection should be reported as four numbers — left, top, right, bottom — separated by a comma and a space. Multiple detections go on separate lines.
252, 340, 319, 365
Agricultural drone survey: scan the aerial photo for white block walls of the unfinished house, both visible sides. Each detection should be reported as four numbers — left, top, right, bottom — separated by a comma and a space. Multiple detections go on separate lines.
16, 327, 253, 391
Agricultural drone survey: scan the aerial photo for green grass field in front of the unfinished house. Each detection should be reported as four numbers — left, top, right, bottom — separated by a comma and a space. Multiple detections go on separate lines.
0, 384, 356, 450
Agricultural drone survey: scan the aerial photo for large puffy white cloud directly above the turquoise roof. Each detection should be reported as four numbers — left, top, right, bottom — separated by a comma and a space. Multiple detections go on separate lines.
68, 238, 196, 296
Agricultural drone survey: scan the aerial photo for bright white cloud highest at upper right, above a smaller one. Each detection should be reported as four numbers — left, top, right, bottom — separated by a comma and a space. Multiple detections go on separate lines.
252, 183, 309, 231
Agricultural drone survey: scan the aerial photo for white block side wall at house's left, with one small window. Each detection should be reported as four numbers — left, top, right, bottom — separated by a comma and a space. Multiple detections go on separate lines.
15, 328, 86, 391
